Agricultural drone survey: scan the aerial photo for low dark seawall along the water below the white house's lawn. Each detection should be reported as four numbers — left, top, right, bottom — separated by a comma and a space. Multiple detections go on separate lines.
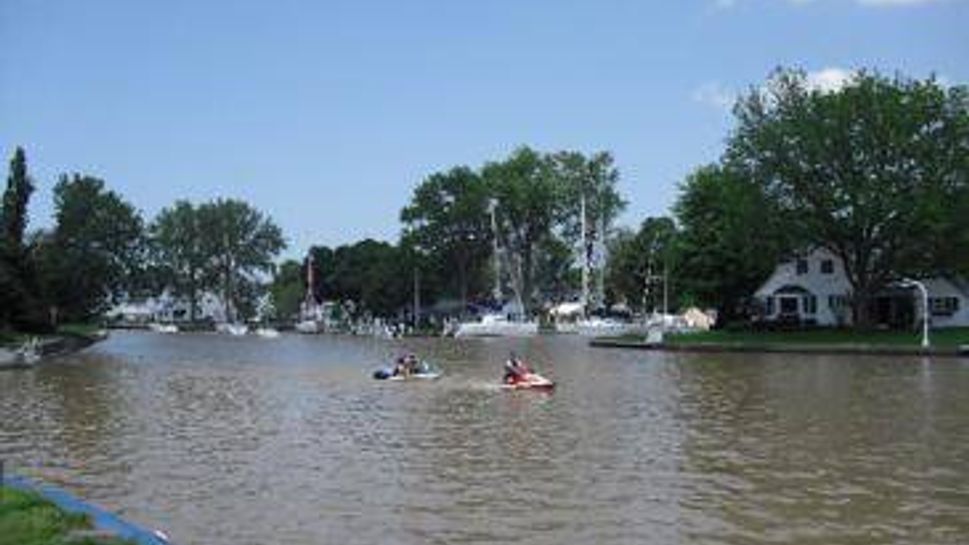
589, 337, 969, 358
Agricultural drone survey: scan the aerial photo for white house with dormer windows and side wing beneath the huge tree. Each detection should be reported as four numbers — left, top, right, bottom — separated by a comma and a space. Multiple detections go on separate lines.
754, 248, 969, 327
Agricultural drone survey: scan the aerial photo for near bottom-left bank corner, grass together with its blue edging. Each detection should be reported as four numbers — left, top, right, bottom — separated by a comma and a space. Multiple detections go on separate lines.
0, 476, 168, 545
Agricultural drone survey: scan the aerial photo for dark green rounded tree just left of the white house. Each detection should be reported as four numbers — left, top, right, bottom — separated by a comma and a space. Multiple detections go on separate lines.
674, 165, 791, 321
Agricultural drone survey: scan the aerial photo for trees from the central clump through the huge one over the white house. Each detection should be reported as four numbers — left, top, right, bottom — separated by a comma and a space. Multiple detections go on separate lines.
278, 69, 969, 327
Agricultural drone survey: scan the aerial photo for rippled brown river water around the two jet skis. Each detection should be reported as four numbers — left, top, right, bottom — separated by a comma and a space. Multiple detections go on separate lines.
0, 333, 969, 545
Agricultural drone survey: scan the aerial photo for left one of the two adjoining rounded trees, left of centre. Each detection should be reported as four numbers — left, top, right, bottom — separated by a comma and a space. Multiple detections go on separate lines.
150, 201, 211, 322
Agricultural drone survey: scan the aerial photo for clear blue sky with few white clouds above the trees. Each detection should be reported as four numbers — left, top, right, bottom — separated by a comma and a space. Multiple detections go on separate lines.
0, 0, 969, 257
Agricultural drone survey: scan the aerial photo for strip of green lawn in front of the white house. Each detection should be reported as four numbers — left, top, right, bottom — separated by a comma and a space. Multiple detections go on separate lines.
664, 327, 969, 347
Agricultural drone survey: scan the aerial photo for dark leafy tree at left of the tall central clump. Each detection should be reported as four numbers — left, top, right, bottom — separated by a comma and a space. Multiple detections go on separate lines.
400, 167, 492, 306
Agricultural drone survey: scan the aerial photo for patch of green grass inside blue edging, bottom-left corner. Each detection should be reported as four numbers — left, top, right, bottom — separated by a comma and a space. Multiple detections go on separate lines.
0, 487, 131, 545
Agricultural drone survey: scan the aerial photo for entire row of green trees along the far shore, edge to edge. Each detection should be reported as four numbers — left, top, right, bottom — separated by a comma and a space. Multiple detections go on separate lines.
0, 69, 969, 328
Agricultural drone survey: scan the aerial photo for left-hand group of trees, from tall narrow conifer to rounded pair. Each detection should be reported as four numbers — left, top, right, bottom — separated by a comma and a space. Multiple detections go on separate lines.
0, 148, 285, 331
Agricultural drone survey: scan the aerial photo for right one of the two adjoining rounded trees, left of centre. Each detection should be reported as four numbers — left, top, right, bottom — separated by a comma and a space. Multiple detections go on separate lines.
197, 199, 286, 321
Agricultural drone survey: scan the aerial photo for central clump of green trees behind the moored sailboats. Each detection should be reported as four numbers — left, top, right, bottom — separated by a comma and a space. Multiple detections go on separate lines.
273, 147, 626, 316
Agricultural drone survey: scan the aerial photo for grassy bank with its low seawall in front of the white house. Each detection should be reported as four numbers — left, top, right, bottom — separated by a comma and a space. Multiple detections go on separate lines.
590, 328, 969, 357
